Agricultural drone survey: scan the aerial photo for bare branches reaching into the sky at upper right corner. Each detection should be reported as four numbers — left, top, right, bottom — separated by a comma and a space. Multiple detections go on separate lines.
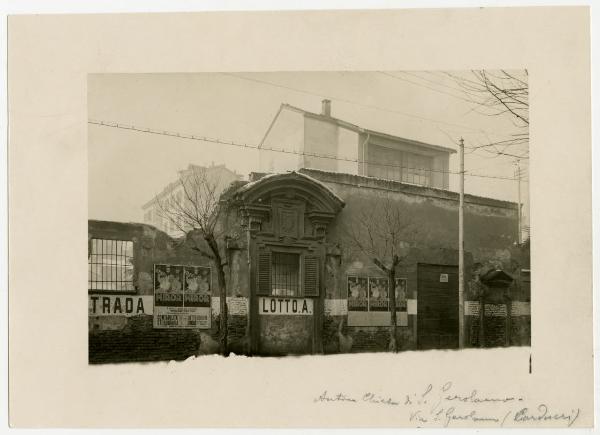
447, 70, 529, 159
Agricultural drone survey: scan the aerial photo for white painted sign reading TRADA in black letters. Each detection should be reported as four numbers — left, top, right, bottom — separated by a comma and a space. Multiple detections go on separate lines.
88, 294, 154, 317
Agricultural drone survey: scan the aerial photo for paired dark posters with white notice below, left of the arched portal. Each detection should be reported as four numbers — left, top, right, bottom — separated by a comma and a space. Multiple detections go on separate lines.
154, 264, 211, 329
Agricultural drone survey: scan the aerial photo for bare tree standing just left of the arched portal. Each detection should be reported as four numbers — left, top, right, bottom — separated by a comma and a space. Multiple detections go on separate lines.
154, 168, 230, 356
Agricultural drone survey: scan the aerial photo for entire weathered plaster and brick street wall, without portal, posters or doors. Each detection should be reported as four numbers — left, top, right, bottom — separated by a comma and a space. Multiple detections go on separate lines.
89, 170, 531, 363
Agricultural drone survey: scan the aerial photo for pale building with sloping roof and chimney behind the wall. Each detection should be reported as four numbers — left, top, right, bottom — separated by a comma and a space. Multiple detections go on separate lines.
259, 100, 456, 189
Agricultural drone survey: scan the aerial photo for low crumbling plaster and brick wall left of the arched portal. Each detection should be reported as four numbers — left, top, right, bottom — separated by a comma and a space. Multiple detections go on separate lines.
88, 220, 249, 364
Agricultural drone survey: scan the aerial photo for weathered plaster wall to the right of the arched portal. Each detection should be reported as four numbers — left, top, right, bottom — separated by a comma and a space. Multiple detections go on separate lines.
301, 169, 530, 353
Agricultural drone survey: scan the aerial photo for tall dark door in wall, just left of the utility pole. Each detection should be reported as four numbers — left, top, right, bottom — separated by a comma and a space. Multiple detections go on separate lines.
417, 264, 458, 349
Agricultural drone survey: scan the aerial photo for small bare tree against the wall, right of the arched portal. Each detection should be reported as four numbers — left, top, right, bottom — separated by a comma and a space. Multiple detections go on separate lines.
345, 196, 418, 352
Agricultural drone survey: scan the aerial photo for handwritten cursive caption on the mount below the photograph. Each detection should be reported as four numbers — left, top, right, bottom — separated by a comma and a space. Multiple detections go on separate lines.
313, 381, 581, 427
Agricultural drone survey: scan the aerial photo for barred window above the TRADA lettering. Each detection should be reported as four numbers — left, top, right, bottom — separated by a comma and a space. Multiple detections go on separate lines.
88, 239, 134, 291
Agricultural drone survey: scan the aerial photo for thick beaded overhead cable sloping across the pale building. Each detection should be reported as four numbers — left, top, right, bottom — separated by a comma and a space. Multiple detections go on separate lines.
88, 119, 516, 181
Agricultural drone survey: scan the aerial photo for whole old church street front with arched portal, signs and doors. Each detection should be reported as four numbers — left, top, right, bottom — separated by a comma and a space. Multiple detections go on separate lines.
88, 169, 530, 363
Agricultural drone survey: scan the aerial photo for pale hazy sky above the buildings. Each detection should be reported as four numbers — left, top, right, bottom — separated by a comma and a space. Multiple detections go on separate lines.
88, 71, 529, 230
